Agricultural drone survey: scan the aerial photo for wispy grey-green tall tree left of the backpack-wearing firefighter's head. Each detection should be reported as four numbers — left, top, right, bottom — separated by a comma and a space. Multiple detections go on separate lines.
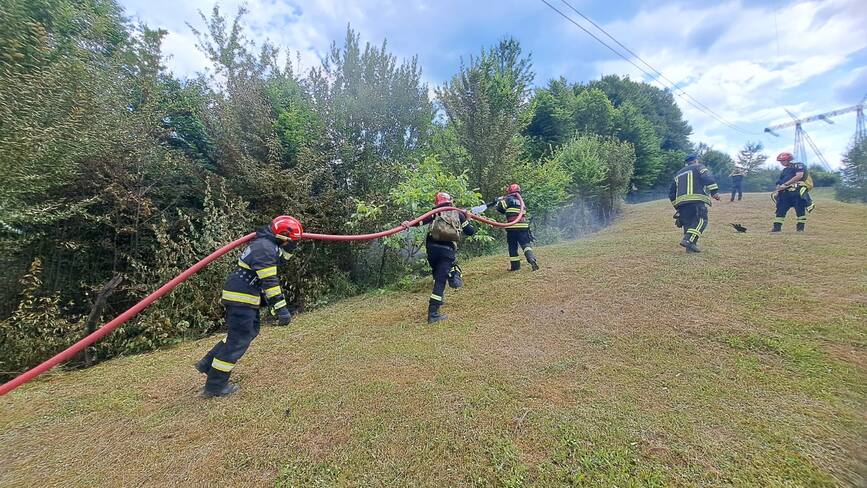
306, 27, 433, 198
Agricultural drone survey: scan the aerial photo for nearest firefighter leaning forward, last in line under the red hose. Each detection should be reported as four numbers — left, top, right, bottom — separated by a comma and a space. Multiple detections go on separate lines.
196, 215, 304, 397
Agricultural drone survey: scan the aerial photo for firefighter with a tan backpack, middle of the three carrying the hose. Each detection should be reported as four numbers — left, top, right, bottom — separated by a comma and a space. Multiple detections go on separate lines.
404, 192, 476, 324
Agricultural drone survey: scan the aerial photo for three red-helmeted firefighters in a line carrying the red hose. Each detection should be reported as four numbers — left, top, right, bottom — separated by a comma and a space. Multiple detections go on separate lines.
196, 183, 539, 397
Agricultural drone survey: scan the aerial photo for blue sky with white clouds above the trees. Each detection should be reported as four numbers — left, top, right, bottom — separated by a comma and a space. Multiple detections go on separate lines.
120, 0, 867, 167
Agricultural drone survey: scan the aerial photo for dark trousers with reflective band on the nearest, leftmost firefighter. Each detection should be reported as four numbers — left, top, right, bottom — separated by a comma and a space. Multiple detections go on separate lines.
199, 305, 259, 393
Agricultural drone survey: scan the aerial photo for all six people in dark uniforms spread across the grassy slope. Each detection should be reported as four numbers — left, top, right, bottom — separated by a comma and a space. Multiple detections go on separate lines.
196, 152, 813, 397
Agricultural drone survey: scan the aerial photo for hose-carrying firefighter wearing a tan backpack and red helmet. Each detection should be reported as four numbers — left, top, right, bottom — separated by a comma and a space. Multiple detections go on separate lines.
404, 192, 476, 324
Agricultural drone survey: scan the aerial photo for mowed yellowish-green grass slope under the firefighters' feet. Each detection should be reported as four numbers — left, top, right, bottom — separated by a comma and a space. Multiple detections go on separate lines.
0, 194, 867, 487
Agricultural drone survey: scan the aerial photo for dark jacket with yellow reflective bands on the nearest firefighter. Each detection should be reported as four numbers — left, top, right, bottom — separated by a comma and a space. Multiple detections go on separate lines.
222, 226, 289, 312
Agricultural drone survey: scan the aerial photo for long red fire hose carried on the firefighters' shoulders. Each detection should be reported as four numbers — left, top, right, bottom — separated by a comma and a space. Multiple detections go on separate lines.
0, 194, 525, 396
